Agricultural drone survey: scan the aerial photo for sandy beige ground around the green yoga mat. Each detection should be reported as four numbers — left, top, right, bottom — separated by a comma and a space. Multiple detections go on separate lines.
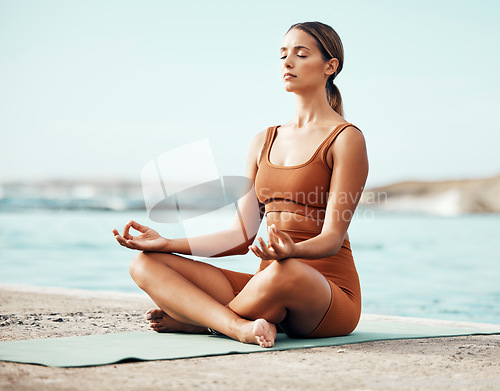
0, 284, 500, 391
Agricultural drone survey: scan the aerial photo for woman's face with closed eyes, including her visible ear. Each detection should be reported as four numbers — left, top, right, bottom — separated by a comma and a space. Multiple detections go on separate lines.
280, 29, 338, 92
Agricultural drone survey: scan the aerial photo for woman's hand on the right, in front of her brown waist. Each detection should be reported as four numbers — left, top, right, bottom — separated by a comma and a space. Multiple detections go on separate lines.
248, 224, 296, 261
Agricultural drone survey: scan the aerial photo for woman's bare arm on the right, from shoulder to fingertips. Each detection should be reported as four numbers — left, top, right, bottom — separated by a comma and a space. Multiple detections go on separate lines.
250, 128, 368, 259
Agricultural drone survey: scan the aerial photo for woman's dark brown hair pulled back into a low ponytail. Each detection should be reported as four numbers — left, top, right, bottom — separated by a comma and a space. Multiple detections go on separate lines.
287, 22, 344, 117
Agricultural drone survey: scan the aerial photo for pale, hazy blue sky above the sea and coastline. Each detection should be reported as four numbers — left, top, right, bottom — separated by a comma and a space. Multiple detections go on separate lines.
0, 0, 500, 187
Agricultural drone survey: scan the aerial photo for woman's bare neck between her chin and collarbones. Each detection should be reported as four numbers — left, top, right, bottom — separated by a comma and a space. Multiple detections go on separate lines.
291, 88, 342, 128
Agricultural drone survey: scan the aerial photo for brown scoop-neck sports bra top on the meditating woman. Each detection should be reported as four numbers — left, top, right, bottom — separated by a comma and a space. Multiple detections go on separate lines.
255, 123, 361, 233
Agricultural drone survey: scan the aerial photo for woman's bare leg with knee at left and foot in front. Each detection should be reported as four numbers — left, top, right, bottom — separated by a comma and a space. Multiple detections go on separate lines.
130, 253, 276, 347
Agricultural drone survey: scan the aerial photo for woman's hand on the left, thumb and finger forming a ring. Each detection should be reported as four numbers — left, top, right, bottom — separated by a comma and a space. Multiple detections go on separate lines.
112, 220, 169, 252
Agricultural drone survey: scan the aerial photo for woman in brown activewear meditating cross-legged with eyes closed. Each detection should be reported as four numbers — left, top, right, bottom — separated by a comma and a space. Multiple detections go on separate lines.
113, 22, 368, 347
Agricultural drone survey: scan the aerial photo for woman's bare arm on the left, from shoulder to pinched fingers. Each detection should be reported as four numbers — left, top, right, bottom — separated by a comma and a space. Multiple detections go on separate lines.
113, 132, 265, 257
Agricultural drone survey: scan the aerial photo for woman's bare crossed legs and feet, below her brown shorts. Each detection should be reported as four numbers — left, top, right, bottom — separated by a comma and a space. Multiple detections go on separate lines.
130, 252, 331, 347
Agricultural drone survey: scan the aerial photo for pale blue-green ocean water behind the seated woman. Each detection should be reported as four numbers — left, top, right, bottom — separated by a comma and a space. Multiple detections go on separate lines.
0, 210, 500, 324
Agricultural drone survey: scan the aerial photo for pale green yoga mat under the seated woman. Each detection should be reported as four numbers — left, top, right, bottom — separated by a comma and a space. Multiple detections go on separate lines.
0, 321, 500, 367
